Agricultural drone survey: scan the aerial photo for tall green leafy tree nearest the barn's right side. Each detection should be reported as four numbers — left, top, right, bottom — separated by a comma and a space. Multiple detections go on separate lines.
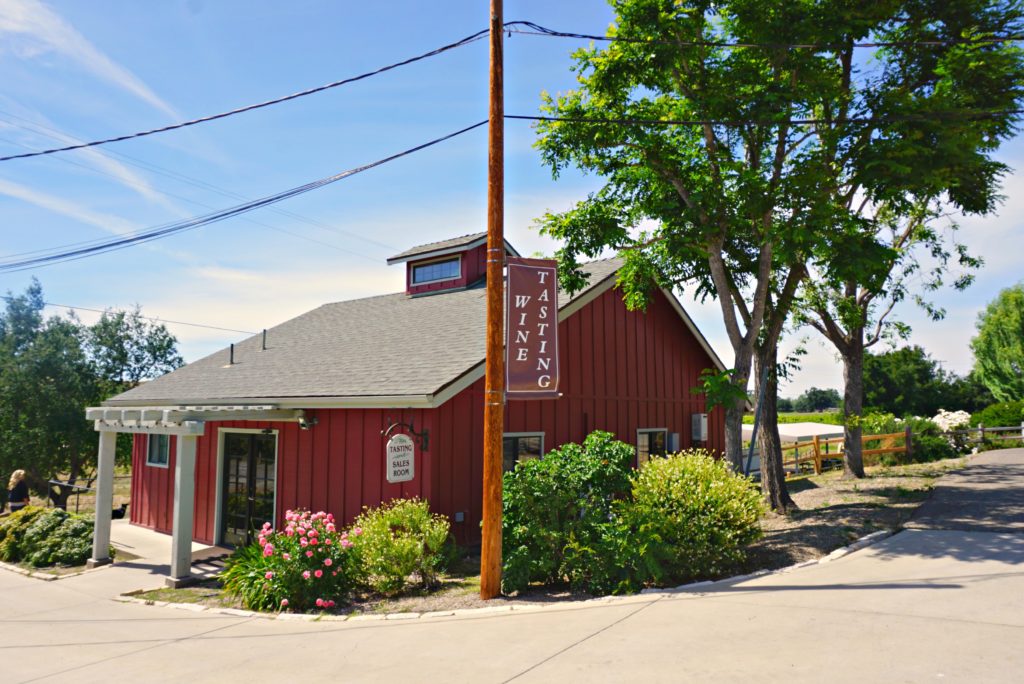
538, 0, 1020, 499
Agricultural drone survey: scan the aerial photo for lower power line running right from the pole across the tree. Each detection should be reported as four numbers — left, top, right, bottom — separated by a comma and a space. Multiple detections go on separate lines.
505, 110, 1024, 126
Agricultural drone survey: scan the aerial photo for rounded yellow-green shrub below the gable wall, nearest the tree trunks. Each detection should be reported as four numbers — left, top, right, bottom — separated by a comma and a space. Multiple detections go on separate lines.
615, 450, 764, 589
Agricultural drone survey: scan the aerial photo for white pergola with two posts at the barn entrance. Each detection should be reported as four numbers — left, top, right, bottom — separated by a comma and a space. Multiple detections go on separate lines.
85, 404, 305, 587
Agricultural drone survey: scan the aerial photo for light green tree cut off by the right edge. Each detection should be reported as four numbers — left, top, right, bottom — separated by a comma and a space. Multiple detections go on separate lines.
971, 285, 1024, 401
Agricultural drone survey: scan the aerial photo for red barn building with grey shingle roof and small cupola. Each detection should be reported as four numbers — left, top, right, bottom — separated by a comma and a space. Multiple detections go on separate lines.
89, 233, 724, 578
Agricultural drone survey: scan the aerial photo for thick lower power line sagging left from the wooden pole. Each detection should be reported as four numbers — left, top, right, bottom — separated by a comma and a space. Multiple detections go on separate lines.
0, 119, 487, 272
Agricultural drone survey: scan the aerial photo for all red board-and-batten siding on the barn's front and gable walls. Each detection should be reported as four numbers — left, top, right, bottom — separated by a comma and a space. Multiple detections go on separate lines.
129, 280, 725, 544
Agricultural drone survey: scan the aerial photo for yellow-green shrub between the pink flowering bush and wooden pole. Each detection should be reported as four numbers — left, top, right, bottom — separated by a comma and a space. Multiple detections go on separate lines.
352, 499, 453, 595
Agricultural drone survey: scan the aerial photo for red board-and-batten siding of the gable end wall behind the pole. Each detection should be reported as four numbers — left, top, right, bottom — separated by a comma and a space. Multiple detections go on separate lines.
431, 290, 725, 542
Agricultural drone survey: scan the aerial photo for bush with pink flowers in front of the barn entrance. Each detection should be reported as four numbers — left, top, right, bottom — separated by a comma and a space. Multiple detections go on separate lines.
221, 511, 359, 612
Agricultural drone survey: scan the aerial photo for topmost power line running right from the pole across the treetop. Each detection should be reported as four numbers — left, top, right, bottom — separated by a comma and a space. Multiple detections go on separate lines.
512, 22, 1024, 50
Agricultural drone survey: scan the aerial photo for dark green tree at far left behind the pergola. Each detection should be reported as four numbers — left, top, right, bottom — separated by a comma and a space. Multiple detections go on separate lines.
0, 281, 180, 507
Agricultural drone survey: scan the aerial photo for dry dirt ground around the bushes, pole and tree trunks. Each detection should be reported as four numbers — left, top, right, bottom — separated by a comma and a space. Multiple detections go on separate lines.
137, 459, 966, 613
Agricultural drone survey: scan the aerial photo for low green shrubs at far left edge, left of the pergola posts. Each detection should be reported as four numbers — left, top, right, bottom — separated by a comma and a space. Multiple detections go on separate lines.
0, 506, 104, 567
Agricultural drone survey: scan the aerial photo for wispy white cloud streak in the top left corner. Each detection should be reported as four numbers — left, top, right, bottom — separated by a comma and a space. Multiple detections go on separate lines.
0, 0, 180, 119
